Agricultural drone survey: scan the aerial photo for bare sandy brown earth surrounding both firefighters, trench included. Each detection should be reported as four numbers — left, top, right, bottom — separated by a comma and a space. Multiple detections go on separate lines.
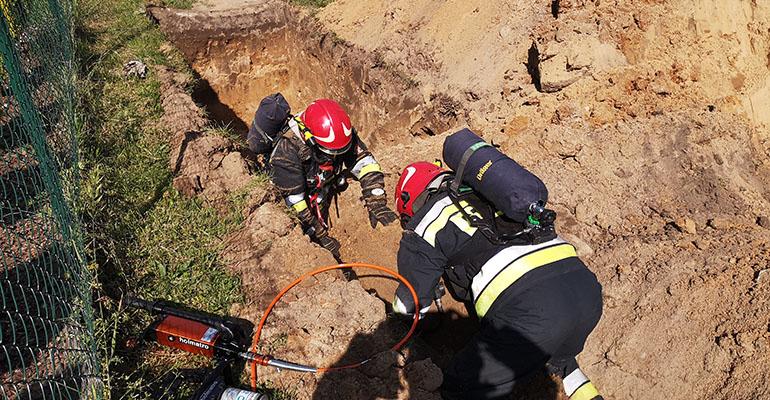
150, 0, 770, 399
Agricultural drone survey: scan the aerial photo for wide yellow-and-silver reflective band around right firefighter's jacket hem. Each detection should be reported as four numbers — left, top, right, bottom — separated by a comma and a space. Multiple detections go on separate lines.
475, 243, 577, 318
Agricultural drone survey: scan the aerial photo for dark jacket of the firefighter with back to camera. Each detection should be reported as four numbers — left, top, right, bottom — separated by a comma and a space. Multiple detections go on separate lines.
394, 191, 587, 317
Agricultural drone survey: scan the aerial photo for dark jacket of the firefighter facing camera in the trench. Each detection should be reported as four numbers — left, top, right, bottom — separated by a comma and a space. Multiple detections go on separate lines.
270, 119, 386, 238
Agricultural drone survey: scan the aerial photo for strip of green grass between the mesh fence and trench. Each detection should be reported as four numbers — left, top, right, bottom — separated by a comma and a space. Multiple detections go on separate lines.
71, 0, 248, 399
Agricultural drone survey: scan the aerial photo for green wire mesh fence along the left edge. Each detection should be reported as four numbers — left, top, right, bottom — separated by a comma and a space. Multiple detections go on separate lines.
0, 0, 101, 399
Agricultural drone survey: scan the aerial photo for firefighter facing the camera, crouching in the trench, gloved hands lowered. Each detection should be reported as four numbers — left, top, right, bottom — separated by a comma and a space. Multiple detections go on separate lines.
270, 99, 398, 261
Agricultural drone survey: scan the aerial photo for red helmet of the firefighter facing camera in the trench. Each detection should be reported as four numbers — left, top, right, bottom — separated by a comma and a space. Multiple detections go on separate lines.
300, 99, 354, 155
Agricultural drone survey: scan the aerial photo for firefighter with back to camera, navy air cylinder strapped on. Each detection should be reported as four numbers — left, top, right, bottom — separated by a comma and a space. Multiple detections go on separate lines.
393, 129, 602, 400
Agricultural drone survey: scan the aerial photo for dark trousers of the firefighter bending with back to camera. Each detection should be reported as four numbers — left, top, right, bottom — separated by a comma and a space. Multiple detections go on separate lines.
441, 269, 602, 400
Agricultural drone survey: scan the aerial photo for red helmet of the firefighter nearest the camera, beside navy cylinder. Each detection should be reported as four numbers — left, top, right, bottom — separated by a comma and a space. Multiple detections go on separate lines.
395, 161, 449, 217
